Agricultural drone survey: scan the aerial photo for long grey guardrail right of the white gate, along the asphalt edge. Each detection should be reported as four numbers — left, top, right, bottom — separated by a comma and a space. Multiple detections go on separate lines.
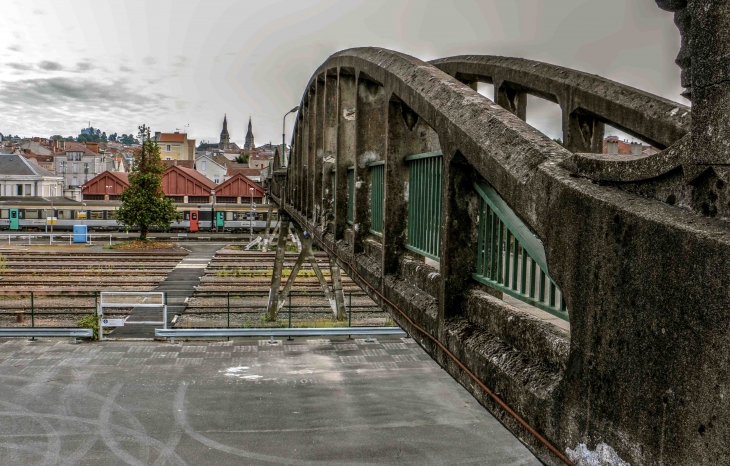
155, 327, 407, 342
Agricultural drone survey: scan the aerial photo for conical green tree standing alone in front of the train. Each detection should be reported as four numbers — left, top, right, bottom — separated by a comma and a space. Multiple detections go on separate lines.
117, 125, 180, 240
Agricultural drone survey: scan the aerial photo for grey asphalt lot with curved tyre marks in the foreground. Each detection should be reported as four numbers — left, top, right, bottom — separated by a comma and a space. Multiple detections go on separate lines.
0, 337, 540, 466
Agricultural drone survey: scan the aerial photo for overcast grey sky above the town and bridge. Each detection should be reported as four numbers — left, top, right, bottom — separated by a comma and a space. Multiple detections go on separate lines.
0, 0, 689, 146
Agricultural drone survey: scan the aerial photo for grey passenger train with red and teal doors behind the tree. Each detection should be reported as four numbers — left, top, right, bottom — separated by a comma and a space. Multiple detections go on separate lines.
0, 197, 278, 233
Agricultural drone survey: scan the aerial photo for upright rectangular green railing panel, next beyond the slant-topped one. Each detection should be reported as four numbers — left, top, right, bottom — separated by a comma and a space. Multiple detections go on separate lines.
405, 151, 443, 261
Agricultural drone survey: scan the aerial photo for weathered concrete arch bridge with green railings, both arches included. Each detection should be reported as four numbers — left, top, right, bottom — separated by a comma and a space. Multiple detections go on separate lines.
269, 41, 730, 465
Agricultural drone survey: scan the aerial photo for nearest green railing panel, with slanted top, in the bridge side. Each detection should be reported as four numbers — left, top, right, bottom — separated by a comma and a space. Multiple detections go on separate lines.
473, 183, 569, 320
